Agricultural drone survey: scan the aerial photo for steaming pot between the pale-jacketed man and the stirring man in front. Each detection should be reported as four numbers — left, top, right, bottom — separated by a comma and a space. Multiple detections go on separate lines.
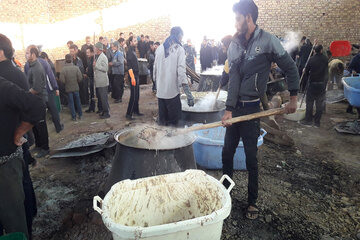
181, 99, 226, 126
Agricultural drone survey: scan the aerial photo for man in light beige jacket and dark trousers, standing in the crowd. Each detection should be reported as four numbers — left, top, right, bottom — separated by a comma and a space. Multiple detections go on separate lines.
93, 42, 110, 119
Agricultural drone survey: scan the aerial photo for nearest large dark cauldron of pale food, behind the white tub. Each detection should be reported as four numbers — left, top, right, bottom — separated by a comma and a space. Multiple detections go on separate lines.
104, 125, 196, 192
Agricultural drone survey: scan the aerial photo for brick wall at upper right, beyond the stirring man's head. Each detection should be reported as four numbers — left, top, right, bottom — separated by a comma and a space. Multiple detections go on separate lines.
255, 0, 360, 46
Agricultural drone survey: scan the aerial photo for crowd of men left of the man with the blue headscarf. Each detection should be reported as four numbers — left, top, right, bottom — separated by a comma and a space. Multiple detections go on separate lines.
0, 33, 160, 239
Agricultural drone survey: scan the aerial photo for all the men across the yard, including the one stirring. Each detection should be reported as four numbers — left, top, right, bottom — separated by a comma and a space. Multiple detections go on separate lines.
0, 0, 360, 239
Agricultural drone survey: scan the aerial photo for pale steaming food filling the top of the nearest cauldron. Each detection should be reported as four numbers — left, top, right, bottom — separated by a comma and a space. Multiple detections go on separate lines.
115, 124, 196, 150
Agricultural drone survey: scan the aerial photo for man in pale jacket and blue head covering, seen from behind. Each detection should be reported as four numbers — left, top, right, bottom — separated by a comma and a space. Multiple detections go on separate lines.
153, 27, 194, 126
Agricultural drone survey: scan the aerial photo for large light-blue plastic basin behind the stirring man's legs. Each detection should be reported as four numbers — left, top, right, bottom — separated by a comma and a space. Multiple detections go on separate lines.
193, 127, 267, 170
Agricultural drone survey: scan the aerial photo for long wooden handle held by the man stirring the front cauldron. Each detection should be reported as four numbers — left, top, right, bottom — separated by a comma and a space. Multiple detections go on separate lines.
181, 108, 285, 133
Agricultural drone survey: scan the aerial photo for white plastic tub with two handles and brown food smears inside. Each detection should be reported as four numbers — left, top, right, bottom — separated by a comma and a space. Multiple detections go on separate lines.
93, 170, 235, 240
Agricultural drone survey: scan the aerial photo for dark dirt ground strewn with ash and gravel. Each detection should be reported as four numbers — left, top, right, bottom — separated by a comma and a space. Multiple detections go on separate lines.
31, 85, 360, 240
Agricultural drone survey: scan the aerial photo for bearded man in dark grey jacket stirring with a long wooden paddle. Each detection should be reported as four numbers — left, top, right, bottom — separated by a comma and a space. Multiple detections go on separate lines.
222, 0, 299, 219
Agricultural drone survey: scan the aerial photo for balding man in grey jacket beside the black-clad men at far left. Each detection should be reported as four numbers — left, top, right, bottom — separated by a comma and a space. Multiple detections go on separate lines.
25, 45, 49, 158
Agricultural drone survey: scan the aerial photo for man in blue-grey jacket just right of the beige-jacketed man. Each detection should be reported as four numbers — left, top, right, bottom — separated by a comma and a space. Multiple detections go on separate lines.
109, 41, 124, 103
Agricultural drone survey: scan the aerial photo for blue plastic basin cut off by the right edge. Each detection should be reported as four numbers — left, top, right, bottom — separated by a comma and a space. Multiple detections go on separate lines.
342, 77, 360, 107
